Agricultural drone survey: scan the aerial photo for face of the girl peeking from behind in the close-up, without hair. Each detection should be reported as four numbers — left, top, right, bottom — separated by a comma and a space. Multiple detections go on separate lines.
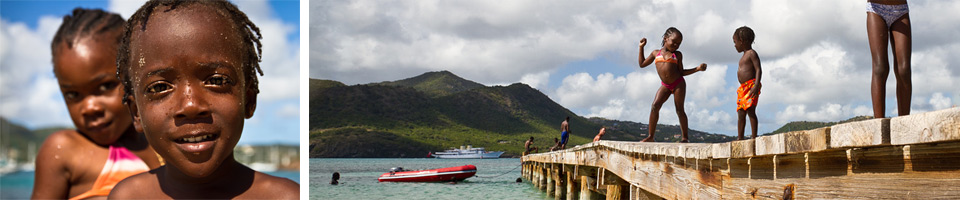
53, 31, 132, 145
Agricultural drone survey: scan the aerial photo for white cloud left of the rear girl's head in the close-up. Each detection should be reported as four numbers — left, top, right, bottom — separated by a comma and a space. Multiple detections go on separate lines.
0, 16, 73, 128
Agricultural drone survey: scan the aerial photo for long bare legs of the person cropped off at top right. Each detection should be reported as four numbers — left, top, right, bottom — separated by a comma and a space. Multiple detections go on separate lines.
867, 12, 913, 118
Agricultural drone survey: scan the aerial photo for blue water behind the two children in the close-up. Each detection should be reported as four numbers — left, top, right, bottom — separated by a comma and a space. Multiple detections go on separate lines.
0, 171, 300, 199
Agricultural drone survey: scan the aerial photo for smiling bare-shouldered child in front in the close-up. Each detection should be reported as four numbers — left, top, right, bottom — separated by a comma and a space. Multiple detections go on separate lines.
109, 0, 300, 199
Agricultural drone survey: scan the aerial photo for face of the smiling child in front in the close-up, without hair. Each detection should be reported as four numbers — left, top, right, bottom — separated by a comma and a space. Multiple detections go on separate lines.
130, 6, 256, 178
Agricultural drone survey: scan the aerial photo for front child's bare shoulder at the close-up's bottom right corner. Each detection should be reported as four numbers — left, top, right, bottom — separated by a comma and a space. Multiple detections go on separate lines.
248, 172, 300, 199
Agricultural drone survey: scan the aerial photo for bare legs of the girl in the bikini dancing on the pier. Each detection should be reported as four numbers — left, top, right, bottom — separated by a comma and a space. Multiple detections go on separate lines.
642, 82, 688, 142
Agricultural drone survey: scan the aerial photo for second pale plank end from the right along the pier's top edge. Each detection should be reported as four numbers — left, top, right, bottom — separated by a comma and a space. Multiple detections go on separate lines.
830, 118, 890, 148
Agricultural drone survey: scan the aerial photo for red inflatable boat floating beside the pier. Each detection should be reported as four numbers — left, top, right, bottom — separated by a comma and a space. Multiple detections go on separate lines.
377, 165, 477, 182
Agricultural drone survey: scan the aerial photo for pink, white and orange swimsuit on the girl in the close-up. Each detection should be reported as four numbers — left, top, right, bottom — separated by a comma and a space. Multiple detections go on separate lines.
70, 145, 150, 199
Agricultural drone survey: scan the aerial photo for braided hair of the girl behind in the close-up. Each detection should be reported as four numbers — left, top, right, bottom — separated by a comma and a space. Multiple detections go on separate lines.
50, 8, 124, 57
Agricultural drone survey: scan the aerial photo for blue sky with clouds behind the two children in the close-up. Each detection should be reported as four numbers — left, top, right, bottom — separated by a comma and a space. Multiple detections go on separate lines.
0, 0, 300, 144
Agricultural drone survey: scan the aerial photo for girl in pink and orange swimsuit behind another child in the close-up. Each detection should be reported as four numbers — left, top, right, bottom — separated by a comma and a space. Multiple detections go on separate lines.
32, 8, 160, 199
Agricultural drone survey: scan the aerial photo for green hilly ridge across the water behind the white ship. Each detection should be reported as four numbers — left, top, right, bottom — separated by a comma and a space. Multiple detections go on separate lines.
309, 71, 724, 157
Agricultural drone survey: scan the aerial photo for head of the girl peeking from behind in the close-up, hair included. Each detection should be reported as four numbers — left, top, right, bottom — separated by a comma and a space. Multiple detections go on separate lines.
50, 8, 134, 145
